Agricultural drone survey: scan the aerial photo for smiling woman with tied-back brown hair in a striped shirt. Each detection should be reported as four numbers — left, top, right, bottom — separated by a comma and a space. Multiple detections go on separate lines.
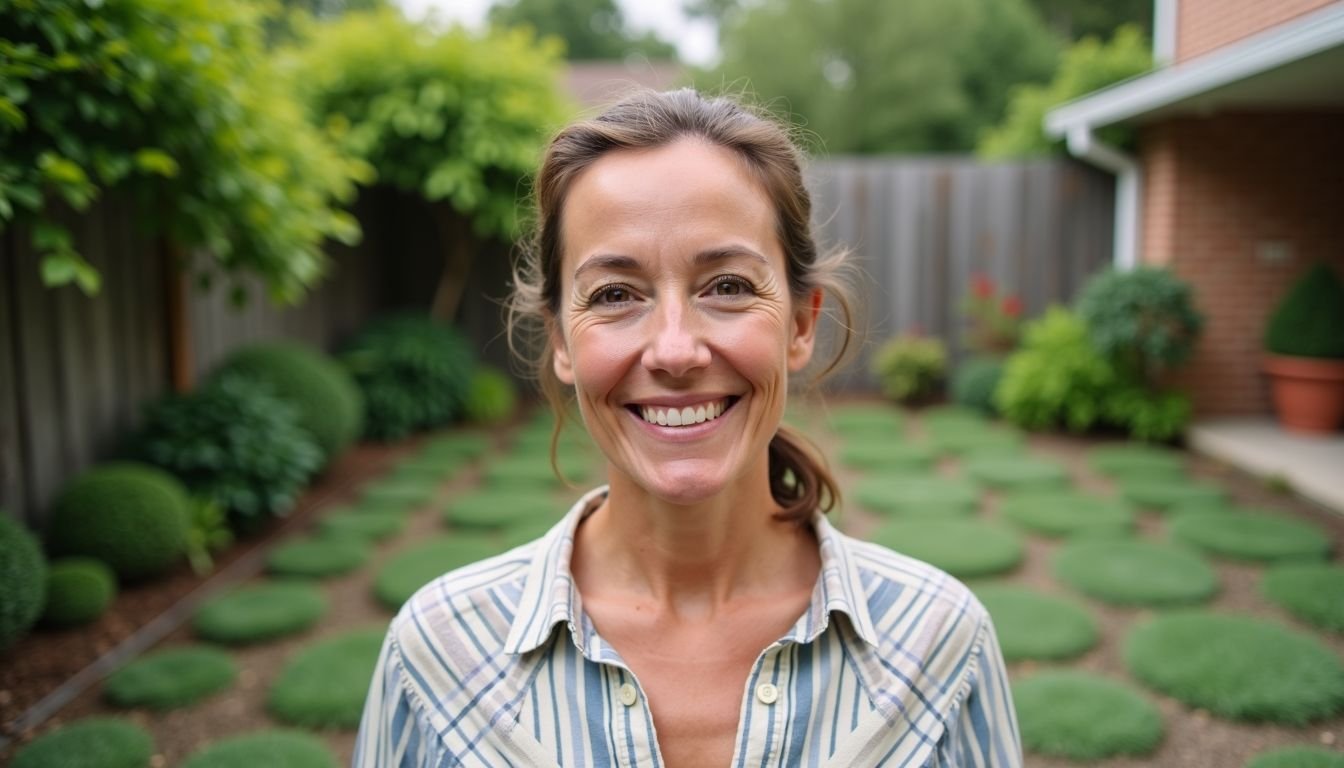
355, 90, 1021, 767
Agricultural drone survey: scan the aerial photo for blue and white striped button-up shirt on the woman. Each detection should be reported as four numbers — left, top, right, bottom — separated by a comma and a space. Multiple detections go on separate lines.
353, 488, 1021, 768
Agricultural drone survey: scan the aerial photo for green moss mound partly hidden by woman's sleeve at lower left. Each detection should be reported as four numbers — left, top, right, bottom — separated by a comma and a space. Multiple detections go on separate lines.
266, 629, 384, 729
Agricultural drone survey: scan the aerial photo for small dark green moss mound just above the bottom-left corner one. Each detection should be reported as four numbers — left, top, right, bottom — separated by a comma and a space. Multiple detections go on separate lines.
102, 646, 238, 710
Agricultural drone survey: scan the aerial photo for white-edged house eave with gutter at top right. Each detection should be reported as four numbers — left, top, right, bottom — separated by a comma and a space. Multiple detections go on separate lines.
1046, 3, 1344, 136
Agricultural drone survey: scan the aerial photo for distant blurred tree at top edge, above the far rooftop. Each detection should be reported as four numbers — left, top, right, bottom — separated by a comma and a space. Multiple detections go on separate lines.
489, 0, 676, 61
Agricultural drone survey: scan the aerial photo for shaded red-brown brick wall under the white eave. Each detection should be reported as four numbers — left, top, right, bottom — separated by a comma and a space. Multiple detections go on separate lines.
1141, 112, 1344, 414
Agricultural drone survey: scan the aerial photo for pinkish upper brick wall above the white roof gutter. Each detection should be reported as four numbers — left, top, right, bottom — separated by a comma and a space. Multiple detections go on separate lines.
1176, 0, 1339, 63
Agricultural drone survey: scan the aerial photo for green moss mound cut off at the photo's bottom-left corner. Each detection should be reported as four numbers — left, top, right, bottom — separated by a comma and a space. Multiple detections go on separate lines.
11, 717, 155, 768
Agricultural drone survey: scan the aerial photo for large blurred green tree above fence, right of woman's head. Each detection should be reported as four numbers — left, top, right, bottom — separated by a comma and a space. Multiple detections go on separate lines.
710, 0, 1056, 155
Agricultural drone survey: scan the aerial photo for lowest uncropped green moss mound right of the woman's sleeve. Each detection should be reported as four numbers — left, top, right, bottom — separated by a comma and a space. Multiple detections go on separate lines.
1012, 670, 1164, 763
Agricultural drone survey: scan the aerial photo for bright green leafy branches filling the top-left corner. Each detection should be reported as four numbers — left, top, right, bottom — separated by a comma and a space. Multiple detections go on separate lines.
0, 0, 368, 301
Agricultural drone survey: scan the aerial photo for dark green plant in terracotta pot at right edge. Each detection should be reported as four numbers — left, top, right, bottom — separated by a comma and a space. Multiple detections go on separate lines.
1265, 264, 1344, 433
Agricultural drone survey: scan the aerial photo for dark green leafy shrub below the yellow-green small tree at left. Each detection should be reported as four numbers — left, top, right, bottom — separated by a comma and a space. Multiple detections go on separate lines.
341, 315, 476, 440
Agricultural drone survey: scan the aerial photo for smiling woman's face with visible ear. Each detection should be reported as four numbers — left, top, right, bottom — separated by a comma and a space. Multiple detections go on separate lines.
552, 139, 821, 503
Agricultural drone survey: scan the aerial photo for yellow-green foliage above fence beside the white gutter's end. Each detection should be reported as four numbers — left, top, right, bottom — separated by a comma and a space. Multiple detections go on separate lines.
977, 25, 1153, 159
